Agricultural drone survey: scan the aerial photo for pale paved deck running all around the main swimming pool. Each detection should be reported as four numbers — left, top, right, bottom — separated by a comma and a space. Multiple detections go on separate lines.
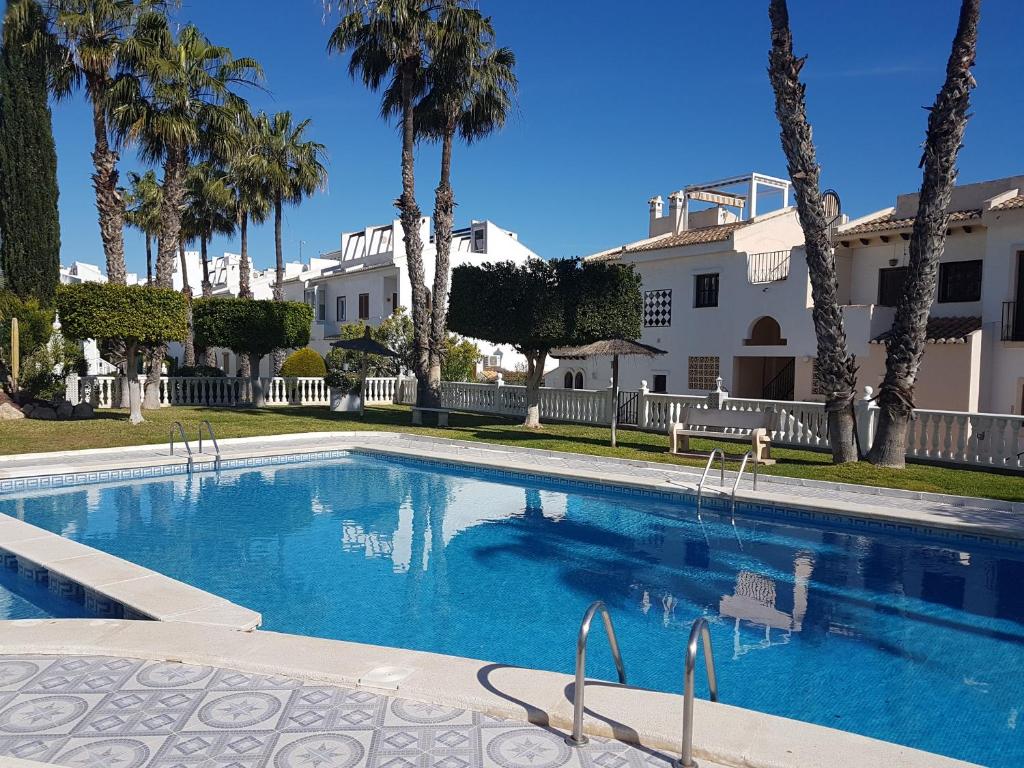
0, 432, 999, 768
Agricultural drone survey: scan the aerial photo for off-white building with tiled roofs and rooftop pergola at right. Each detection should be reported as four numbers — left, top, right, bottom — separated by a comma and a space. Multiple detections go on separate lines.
547, 174, 1024, 413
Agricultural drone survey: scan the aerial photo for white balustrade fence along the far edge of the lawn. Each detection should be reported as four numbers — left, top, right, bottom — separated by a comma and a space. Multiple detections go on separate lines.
69, 376, 1024, 469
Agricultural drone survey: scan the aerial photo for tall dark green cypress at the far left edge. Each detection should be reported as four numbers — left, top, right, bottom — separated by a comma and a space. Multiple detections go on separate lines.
0, 0, 60, 304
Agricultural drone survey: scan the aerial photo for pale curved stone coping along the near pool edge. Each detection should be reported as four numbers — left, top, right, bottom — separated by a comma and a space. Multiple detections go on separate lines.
0, 620, 971, 768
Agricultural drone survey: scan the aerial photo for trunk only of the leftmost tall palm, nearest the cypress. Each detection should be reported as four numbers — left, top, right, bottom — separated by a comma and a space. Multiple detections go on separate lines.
86, 75, 127, 286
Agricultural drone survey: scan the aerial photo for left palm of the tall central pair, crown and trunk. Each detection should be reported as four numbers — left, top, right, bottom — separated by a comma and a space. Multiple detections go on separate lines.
328, 0, 437, 402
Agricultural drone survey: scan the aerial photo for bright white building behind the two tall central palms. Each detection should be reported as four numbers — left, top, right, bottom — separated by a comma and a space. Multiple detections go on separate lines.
284, 217, 540, 370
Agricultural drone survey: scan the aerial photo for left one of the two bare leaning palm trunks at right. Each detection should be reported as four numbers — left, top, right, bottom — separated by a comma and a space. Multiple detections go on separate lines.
768, 0, 857, 464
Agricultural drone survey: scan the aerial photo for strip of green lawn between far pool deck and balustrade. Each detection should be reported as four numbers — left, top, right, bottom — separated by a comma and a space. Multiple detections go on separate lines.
0, 406, 1024, 501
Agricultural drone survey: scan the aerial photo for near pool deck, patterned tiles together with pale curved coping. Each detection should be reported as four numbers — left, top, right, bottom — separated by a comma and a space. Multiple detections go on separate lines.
0, 620, 969, 768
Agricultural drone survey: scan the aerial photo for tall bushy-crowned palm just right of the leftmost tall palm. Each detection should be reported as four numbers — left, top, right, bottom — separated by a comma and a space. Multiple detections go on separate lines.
112, 13, 263, 408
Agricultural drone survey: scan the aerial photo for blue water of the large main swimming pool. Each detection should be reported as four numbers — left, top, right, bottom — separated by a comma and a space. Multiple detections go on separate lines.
0, 455, 1024, 766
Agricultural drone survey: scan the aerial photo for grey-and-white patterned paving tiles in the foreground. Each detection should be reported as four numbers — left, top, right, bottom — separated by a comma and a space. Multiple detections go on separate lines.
0, 656, 670, 768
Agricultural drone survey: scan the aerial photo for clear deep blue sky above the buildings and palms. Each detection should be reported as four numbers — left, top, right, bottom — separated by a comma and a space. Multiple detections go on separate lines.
25, 0, 1024, 273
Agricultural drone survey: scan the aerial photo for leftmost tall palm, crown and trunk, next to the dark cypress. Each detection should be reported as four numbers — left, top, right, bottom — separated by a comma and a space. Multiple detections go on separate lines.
9, 0, 167, 285
